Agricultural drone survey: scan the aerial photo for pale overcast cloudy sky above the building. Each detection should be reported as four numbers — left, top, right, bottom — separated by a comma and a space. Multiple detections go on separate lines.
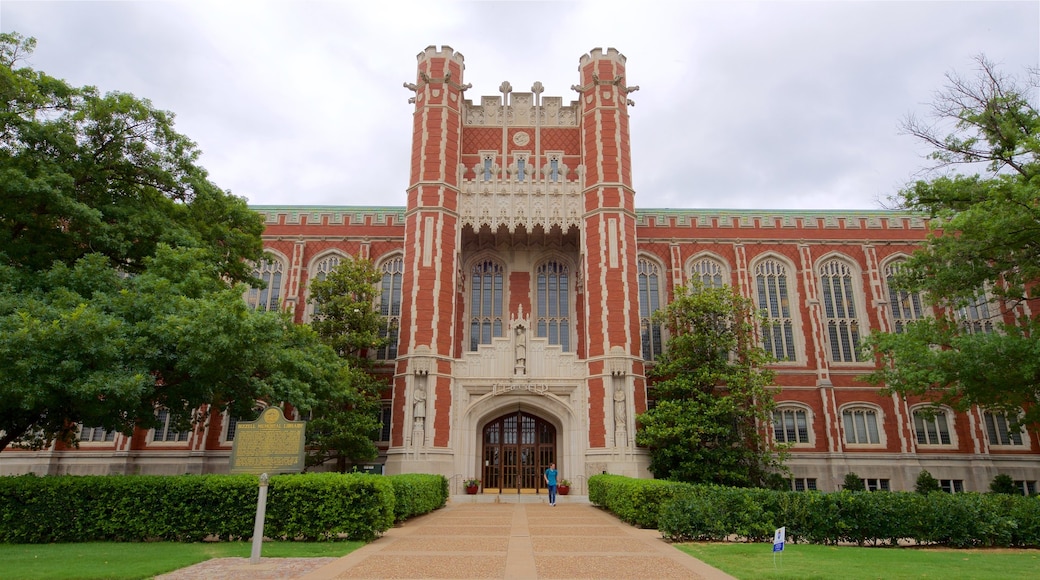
0, 0, 1040, 210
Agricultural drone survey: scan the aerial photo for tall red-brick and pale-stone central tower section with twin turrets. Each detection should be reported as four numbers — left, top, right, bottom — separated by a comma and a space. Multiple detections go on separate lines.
387, 47, 649, 493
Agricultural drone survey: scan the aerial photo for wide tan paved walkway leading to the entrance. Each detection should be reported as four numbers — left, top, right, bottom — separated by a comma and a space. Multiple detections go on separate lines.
302, 496, 732, 580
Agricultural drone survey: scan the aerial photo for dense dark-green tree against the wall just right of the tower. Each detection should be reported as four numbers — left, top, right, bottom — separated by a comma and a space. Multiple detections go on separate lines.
636, 283, 783, 486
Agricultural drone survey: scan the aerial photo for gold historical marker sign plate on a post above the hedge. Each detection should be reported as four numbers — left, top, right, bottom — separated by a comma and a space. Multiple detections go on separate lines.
231, 406, 307, 474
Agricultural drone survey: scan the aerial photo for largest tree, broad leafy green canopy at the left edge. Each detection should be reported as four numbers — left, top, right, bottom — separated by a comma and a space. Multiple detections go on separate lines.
0, 33, 352, 450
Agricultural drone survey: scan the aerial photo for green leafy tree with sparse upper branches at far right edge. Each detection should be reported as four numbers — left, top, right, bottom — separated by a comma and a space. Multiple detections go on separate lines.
865, 57, 1040, 424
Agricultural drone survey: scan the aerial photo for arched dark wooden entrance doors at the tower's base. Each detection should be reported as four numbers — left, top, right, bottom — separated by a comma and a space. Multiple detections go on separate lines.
482, 411, 556, 494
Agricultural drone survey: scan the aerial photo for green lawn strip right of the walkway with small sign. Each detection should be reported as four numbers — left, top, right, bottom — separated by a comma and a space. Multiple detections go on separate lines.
676, 544, 1040, 580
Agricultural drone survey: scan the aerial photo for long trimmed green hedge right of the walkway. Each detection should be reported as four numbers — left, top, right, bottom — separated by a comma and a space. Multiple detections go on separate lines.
589, 475, 1040, 548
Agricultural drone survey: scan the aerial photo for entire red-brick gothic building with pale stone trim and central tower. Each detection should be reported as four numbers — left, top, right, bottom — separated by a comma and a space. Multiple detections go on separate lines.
0, 47, 1040, 493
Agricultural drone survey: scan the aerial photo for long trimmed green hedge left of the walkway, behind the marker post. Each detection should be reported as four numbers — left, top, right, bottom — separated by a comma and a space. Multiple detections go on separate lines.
0, 473, 447, 544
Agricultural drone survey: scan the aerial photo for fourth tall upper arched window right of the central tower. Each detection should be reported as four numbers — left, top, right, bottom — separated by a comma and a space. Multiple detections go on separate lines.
820, 259, 859, 363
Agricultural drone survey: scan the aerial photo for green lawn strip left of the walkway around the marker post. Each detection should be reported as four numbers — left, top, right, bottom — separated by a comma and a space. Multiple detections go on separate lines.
0, 542, 364, 580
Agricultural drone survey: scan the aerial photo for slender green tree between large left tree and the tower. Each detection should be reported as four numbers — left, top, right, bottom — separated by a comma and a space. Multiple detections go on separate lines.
307, 258, 387, 471
